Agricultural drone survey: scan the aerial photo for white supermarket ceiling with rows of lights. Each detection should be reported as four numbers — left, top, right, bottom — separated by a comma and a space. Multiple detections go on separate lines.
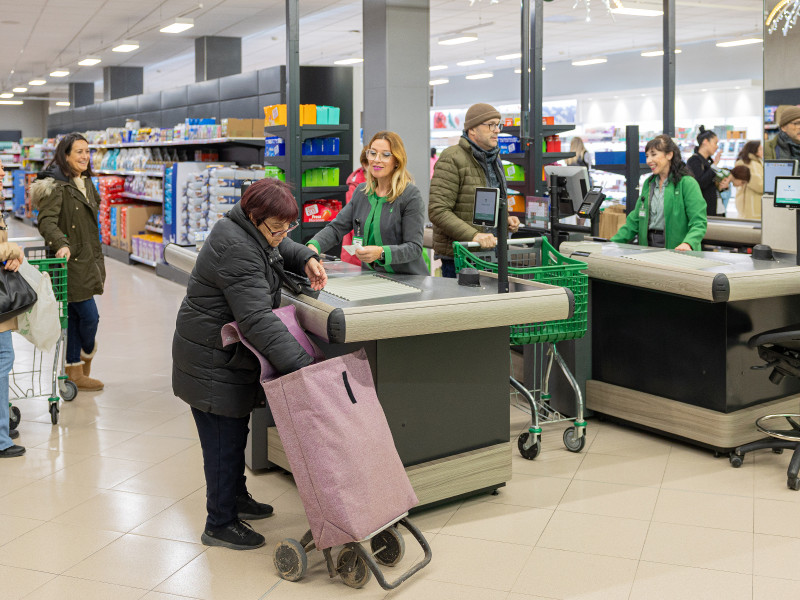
0, 0, 763, 98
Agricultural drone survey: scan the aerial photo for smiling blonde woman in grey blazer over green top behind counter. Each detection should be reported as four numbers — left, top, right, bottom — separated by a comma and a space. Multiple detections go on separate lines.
308, 131, 428, 275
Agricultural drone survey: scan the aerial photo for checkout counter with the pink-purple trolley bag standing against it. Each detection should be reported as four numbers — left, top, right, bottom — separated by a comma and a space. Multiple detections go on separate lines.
165, 247, 573, 505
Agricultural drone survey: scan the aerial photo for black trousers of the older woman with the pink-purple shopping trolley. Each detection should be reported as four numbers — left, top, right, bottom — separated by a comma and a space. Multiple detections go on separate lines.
192, 408, 250, 529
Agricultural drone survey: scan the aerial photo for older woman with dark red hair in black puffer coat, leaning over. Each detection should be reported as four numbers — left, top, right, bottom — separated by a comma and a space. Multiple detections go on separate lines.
172, 179, 327, 550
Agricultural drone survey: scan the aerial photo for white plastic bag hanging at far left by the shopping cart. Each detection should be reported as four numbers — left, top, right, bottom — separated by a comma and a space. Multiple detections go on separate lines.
17, 262, 61, 352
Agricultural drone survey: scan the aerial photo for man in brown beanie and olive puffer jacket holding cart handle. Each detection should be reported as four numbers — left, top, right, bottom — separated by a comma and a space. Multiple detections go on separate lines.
428, 104, 519, 277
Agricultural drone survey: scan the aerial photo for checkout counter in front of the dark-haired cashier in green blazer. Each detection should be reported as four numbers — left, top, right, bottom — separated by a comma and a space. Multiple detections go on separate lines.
560, 242, 800, 451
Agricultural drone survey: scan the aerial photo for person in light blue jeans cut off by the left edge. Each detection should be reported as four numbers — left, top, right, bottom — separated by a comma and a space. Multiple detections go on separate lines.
0, 164, 25, 458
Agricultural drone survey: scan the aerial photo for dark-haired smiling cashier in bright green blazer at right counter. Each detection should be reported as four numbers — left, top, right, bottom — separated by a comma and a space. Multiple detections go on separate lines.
611, 134, 708, 250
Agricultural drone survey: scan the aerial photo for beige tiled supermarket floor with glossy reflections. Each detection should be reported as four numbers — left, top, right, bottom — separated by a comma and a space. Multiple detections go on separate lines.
0, 227, 800, 600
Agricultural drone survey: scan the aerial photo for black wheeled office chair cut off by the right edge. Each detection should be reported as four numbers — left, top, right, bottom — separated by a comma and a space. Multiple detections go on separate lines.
730, 324, 800, 490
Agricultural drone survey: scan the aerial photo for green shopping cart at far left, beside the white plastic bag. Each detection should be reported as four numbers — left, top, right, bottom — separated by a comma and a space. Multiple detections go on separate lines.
9, 246, 78, 425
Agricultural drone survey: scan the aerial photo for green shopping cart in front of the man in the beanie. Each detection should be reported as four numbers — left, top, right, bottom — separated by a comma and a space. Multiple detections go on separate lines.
453, 237, 589, 460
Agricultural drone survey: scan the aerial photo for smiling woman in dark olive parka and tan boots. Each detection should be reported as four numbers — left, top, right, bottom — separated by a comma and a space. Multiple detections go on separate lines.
31, 133, 106, 391
